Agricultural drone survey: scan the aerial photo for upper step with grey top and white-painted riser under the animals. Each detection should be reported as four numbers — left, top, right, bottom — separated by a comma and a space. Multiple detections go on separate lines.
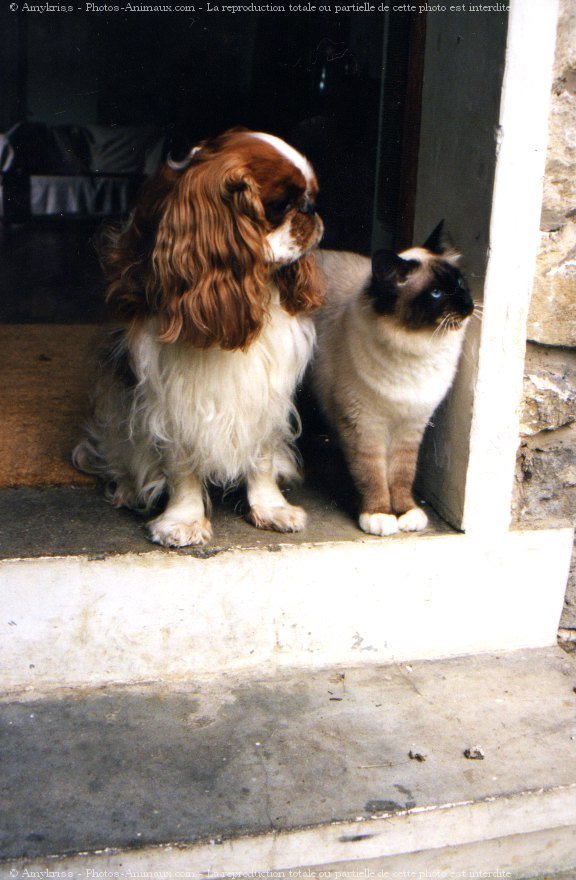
0, 489, 572, 693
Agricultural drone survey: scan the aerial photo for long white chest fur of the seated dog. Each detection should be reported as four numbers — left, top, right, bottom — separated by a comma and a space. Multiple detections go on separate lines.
135, 303, 315, 482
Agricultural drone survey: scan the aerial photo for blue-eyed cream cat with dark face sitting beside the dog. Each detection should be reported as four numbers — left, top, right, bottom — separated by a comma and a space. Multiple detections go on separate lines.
311, 221, 474, 535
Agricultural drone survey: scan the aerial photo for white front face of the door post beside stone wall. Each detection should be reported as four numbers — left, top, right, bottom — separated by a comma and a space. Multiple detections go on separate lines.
462, 0, 558, 532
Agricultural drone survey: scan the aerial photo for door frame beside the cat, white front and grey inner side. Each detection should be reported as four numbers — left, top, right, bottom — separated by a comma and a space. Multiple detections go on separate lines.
415, 0, 558, 532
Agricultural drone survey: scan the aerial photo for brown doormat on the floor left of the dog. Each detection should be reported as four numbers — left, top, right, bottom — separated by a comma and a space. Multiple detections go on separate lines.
0, 324, 102, 488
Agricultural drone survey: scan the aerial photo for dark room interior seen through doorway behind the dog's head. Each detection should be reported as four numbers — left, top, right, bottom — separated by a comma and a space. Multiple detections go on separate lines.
0, 10, 424, 323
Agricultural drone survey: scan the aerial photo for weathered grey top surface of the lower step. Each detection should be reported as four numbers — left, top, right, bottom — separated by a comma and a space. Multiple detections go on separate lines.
0, 648, 576, 859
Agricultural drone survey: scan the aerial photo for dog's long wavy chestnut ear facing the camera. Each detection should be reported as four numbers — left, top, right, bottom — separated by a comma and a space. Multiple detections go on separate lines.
149, 156, 269, 350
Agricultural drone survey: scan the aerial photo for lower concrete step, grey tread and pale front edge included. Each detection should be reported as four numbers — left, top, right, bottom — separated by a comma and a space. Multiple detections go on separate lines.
0, 648, 576, 878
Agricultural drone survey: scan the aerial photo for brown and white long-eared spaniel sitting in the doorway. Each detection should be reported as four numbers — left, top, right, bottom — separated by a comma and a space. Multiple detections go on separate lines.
73, 130, 323, 547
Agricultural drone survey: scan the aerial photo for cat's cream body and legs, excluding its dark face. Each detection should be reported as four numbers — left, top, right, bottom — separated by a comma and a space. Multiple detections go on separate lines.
311, 248, 466, 535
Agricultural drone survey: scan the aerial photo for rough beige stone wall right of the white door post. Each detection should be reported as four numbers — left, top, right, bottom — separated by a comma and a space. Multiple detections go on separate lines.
514, 0, 576, 629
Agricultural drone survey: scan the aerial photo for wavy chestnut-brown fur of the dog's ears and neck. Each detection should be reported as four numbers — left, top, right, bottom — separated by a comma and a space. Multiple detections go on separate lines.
102, 135, 324, 351
